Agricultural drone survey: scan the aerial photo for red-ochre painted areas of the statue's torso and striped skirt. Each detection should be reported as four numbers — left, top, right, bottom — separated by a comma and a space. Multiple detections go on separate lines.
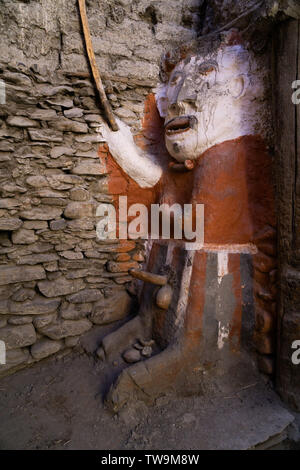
99, 95, 276, 360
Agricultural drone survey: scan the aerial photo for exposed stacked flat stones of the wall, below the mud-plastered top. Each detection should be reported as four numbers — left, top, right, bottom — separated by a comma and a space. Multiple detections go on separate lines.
0, 67, 151, 373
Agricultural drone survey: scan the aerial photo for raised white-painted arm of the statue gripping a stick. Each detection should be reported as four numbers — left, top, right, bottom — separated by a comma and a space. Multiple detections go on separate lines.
98, 119, 162, 188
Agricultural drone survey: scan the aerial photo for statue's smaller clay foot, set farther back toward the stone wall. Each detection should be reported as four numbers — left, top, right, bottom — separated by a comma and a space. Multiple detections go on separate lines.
97, 316, 143, 361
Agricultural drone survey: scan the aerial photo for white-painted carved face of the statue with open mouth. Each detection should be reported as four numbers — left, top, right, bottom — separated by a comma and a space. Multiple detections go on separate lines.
157, 46, 251, 162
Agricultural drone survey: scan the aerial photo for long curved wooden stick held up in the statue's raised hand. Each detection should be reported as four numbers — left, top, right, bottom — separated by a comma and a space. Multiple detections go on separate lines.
78, 0, 119, 131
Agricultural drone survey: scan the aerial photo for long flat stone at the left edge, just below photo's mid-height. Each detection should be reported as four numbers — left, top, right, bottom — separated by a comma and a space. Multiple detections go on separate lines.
0, 266, 46, 285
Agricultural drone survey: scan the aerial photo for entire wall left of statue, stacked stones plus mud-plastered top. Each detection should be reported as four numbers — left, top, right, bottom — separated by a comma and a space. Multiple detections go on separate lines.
0, 0, 202, 375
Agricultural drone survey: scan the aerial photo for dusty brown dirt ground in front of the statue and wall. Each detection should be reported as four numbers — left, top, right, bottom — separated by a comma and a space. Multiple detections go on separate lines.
0, 326, 295, 450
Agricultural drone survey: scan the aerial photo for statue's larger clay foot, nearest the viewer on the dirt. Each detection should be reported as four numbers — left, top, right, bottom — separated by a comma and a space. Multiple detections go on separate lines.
106, 345, 182, 413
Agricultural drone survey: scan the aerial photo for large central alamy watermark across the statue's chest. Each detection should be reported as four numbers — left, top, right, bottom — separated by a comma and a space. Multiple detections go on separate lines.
96, 196, 204, 245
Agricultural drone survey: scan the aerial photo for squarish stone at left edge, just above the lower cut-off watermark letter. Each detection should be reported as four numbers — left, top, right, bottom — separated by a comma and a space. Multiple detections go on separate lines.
0, 324, 36, 349
